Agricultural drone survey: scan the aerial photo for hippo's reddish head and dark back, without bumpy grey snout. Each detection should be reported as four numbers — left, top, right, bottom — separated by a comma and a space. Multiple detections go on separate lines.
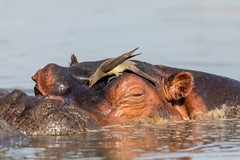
33, 58, 240, 122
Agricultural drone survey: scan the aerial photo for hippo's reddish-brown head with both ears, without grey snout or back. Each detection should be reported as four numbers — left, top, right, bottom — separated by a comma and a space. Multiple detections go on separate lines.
32, 55, 193, 126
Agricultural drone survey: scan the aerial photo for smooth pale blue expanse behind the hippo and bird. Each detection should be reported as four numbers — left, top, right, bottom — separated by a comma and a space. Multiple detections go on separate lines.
0, 0, 240, 93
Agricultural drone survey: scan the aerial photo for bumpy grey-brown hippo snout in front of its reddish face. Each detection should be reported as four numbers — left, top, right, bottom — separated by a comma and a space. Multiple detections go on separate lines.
0, 90, 100, 135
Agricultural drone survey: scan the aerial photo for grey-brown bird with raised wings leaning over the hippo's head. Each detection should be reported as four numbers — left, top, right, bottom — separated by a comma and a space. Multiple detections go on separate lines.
89, 47, 157, 88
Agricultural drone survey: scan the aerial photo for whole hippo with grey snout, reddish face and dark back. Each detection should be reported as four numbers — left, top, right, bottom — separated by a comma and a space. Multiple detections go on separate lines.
0, 48, 240, 135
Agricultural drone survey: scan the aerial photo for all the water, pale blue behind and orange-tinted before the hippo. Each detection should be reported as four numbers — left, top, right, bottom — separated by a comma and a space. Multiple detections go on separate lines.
0, 0, 240, 159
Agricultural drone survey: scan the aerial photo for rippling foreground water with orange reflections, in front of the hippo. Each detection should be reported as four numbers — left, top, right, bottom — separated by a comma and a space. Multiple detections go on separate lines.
0, 119, 240, 160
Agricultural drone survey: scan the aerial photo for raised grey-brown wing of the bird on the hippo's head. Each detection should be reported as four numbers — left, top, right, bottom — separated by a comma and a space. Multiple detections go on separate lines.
101, 47, 140, 73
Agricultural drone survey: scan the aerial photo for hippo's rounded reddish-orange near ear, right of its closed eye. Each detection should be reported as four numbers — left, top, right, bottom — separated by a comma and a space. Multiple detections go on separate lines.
164, 71, 193, 101
